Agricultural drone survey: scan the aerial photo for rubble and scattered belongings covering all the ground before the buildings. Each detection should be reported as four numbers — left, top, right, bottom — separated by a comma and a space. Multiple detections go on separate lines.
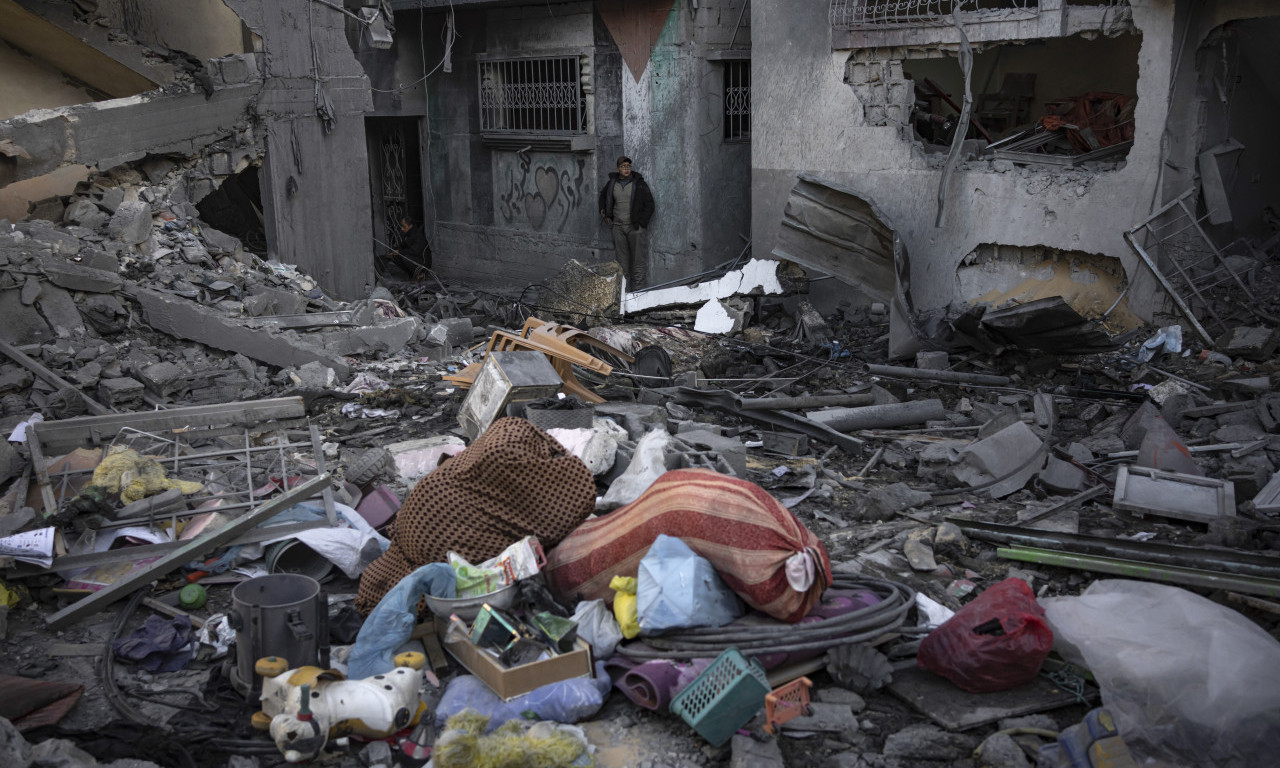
0, 185, 1280, 768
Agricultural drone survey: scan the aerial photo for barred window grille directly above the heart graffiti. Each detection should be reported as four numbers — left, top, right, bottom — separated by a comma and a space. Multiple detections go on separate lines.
480, 56, 586, 133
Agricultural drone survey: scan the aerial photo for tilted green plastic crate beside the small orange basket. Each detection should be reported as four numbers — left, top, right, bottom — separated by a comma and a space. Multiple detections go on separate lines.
671, 648, 769, 746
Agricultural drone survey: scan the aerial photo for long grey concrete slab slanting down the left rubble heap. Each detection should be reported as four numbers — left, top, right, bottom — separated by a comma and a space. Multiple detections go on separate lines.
127, 284, 351, 379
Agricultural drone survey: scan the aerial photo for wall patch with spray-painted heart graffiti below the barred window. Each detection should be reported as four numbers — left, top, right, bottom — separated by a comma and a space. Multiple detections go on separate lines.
494, 152, 595, 232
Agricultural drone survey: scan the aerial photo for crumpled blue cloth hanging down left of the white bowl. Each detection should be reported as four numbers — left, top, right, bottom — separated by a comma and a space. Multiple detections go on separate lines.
347, 563, 457, 680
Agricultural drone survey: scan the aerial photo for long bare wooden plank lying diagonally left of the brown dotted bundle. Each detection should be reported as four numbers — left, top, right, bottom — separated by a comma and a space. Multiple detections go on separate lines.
46, 474, 329, 630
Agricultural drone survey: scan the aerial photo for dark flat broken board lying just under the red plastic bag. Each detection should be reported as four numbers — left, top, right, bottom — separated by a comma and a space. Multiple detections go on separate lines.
888, 667, 1089, 731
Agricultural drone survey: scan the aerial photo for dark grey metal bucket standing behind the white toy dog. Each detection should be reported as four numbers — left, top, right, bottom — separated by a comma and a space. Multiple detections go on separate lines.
230, 573, 329, 696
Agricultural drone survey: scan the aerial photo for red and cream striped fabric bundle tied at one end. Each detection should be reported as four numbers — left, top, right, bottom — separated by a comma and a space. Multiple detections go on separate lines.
545, 470, 831, 622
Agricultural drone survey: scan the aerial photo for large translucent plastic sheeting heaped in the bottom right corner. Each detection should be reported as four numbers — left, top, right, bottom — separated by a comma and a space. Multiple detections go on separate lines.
1041, 579, 1280, 768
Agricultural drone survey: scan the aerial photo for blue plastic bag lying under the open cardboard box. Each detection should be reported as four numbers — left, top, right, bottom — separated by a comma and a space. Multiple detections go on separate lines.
435, 662, 612, 733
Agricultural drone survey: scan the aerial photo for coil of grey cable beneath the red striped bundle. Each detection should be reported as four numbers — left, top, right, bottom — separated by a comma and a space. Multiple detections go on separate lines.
617, 573, 924, 660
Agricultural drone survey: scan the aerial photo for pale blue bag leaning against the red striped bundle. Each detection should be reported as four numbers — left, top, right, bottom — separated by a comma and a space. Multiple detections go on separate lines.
636, 535, 742, 635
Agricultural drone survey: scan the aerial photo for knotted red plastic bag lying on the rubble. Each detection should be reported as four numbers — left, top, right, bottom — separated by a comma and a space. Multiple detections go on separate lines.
915, 579, 1053, 694
